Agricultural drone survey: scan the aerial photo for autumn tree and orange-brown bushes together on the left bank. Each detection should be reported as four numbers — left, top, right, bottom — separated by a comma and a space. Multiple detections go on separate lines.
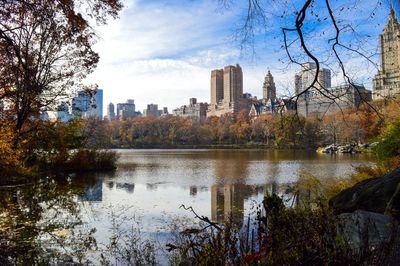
0, 0, 122, 180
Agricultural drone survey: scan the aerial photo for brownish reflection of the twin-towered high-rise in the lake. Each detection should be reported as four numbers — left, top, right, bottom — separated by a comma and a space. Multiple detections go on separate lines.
211, 184, 256, 225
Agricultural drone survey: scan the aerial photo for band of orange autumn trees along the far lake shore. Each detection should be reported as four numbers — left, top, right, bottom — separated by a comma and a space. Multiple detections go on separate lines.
85, 96, 399, 149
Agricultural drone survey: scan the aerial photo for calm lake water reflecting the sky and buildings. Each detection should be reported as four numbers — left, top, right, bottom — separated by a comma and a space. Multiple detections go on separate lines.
0, 150, 371, 262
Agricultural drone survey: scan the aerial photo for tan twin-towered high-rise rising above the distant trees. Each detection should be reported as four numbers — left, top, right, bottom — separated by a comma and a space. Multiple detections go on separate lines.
207, 64, 251, 116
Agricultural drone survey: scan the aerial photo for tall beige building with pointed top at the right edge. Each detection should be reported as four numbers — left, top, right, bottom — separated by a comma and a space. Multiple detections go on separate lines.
372, 7, 400, 100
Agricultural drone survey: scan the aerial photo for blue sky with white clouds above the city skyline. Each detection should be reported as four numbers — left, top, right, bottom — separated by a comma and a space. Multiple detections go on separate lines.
87, 0, 400, 114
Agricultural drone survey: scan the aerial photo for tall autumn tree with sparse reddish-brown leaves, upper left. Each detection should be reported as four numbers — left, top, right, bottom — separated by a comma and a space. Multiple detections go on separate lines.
0, 0, 122, 146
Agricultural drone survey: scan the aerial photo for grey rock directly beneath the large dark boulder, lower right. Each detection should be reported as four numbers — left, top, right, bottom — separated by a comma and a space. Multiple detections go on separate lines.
338, 210, 397, 250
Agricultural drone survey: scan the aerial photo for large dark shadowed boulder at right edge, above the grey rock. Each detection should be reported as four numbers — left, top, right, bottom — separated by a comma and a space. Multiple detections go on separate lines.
329, 167, 400, 220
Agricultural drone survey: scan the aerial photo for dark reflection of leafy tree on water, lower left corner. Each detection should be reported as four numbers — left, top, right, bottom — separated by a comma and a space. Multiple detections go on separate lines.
0, 176, 99, 265
